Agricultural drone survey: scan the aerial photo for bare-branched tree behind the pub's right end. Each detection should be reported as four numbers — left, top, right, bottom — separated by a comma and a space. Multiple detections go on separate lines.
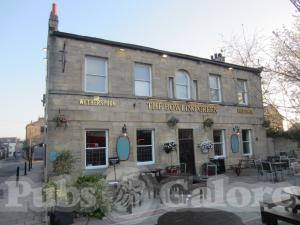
223, 18, 300, 126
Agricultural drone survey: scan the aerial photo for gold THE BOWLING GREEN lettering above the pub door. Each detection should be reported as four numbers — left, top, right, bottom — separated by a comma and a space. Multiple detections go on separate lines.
146, 100, 218, 113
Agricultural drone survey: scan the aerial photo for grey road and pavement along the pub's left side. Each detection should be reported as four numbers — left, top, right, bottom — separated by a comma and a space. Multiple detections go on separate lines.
0, 157, 45, 225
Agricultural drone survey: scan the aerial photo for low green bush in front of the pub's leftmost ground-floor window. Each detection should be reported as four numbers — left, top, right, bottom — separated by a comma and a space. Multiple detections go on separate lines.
75, 175, 112, 219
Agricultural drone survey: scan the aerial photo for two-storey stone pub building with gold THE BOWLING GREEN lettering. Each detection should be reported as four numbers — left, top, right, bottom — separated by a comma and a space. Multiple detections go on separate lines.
45, 4, 267, 179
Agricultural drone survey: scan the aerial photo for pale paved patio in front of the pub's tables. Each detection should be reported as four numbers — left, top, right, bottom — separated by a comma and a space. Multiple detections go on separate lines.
74, 169, 295, 225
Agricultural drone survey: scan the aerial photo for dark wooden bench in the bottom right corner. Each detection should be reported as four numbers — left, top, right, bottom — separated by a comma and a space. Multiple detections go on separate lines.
260, 199, 300, 225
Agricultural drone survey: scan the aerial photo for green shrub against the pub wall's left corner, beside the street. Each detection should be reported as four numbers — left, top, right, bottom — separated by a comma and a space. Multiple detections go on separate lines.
53, 150, 74, 175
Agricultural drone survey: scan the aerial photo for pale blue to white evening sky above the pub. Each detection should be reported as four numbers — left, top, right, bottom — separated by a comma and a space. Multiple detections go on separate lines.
0, 0, 296, 139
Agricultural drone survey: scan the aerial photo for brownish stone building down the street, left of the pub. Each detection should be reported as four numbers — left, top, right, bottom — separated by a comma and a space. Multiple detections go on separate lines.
26, 117, 45, 160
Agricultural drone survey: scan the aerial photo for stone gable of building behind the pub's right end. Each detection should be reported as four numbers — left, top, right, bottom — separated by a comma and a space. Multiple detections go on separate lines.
264, 104, 283, 131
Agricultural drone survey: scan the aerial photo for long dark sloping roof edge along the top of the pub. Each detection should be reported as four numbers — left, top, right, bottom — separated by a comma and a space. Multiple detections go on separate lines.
52, 31, 262, 75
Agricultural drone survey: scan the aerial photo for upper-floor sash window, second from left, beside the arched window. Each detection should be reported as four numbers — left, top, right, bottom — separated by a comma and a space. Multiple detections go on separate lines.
134, 63, 152, 96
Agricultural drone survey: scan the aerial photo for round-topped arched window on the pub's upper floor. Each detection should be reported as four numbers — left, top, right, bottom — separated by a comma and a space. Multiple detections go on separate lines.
175, 70, 190, 99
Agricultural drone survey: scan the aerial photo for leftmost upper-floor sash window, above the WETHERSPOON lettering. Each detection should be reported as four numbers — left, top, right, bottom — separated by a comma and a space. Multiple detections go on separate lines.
85, 56, 108, 93
